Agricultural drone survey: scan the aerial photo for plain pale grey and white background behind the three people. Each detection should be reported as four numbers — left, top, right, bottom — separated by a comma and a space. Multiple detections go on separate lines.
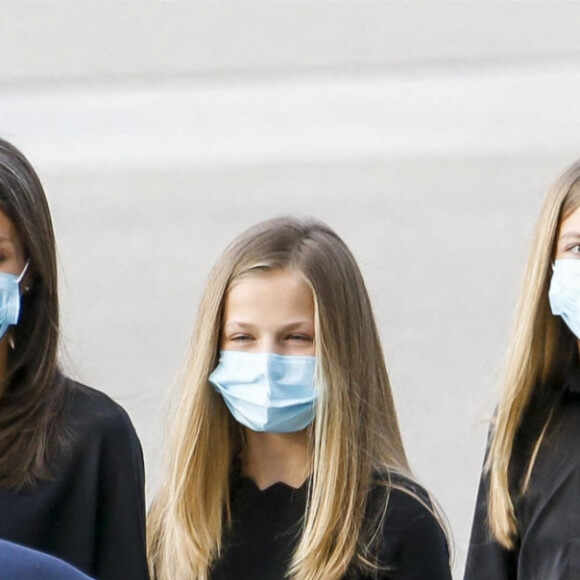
0, 0, 580, 578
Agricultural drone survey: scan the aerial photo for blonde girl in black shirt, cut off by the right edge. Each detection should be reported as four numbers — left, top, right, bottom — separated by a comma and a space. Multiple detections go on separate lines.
465, 162, 580, 580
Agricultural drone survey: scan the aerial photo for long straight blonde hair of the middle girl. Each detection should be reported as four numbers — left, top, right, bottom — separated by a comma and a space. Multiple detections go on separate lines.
149, 218, 410, 580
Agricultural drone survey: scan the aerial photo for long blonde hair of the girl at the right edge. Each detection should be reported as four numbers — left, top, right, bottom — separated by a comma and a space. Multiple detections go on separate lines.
486, 161, 580, 548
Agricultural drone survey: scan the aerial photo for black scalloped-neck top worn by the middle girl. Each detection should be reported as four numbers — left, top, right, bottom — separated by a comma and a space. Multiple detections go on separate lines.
210, 477, 451, 580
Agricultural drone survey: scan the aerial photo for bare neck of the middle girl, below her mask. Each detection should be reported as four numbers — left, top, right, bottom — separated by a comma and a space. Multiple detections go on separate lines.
242, 429, 309, 489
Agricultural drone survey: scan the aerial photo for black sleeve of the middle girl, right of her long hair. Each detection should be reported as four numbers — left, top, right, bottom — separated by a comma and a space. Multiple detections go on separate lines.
379, 490, 451, 580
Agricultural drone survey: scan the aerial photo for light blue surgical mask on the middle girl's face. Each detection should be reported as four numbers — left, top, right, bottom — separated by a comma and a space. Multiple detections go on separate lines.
209, 350, 316, 433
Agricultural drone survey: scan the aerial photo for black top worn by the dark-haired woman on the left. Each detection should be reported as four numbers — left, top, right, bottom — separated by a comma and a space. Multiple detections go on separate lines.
0, 384, 148, 580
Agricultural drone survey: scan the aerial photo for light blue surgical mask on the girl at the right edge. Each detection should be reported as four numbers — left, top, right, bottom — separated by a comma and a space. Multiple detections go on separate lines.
548, 259, 580, 339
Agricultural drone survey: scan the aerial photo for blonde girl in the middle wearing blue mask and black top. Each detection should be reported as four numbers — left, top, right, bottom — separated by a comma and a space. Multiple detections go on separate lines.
149, 218, 451, 580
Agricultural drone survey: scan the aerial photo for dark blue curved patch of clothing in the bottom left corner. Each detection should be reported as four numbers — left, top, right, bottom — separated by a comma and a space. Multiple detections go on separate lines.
0, 540, 90, 580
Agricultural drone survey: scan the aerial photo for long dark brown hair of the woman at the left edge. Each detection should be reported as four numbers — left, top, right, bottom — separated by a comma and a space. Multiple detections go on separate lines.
0, 139, 67, 488
